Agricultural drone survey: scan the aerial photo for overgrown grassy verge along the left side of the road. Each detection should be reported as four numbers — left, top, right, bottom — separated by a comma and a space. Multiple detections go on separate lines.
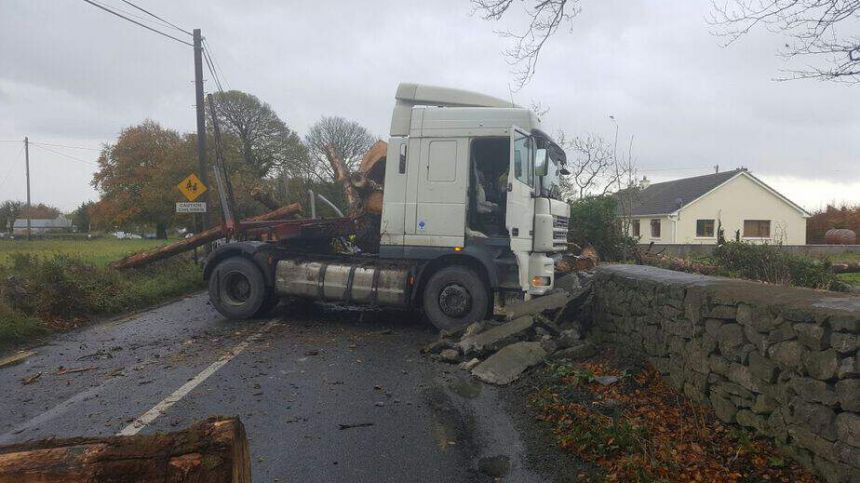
0, 253, 204, 349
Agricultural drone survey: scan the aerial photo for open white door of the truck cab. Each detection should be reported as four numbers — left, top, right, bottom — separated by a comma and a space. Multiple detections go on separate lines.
505, 126, 535, 254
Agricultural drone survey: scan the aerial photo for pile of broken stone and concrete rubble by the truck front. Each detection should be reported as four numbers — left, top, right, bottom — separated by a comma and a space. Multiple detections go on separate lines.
421, 272, 596, 385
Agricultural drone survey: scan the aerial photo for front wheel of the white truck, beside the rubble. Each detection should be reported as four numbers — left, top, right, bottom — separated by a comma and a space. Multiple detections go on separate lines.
422, 266, 490, 330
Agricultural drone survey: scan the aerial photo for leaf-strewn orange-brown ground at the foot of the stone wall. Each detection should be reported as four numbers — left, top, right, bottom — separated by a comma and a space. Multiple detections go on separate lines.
507, 347, 815, 482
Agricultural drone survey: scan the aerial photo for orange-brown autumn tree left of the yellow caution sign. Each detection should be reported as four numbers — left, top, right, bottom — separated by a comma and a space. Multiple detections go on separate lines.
92, 120, 196, 238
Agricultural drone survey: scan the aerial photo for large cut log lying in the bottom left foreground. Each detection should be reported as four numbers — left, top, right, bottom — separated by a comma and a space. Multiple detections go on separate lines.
0, 417, 251, 483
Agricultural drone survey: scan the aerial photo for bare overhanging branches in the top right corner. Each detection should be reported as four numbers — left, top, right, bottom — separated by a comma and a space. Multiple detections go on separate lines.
710, 0, 860, 83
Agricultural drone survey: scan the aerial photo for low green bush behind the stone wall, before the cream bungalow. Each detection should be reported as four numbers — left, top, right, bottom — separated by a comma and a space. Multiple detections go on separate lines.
713, 242, 842, 290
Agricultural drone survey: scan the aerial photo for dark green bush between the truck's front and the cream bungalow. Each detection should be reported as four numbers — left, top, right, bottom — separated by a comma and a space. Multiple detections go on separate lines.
568, 196, 636, 260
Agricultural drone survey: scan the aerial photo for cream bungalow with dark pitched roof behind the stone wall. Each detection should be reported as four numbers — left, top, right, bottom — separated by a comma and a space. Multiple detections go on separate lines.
618, 169, 810, 245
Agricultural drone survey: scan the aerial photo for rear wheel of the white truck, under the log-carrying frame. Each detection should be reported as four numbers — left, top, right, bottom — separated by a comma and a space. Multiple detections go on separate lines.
209, 257, 274, 319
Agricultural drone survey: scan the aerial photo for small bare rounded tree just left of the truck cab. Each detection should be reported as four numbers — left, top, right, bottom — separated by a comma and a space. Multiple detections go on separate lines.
305, 116, 377, 181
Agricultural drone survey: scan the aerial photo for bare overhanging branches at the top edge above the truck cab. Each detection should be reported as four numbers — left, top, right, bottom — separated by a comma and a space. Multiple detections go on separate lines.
471, 0, 580, 90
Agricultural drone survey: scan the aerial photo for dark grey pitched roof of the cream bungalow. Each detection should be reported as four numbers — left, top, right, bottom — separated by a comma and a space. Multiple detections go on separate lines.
618, 168, 809, 216
